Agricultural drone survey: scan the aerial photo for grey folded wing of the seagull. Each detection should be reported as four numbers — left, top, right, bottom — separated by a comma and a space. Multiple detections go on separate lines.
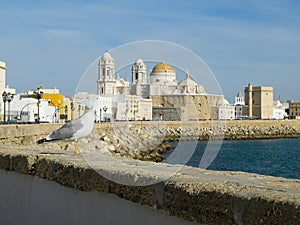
46, 118, 83, 140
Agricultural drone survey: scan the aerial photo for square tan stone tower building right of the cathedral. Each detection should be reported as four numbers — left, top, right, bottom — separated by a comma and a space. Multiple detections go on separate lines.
245, 83, 274, 119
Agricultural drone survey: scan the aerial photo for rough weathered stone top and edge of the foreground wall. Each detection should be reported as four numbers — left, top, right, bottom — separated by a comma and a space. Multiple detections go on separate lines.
0, 145, 300, 225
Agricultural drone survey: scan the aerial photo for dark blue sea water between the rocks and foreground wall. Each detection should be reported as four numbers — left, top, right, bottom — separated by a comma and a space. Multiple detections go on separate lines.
165, 138, 300, 179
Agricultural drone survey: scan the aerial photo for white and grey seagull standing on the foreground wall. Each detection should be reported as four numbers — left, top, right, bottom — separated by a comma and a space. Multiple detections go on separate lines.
36, 109, 95, 154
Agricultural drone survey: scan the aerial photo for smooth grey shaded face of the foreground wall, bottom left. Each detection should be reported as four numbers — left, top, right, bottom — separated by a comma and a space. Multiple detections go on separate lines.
0, 170, 203, 225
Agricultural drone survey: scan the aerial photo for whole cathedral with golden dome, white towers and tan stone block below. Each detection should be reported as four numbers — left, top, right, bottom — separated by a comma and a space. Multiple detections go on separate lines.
97, 52, 224, 121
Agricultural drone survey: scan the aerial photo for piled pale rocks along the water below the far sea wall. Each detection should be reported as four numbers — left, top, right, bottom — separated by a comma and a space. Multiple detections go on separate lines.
89, 121, 300, 162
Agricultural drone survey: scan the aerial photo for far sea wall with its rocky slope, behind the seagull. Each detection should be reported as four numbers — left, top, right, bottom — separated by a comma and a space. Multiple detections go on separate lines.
0, 120, 300, 162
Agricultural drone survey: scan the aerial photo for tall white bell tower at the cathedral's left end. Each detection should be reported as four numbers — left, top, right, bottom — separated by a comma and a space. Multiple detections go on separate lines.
97, 51, 116, 95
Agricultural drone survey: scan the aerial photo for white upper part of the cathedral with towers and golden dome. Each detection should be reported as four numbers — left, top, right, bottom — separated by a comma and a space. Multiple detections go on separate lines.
97, 52, 205, 98
